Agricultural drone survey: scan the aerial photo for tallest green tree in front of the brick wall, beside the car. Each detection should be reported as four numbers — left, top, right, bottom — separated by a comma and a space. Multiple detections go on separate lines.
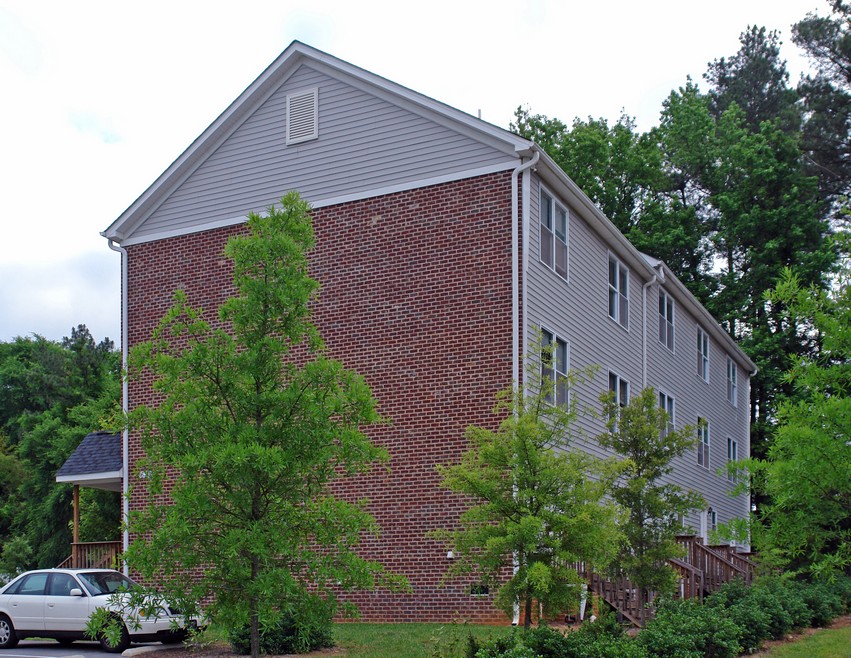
127, 192, 404, 656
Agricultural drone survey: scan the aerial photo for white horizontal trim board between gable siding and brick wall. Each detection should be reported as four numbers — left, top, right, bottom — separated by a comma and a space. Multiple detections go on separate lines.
121, 160, 517, 247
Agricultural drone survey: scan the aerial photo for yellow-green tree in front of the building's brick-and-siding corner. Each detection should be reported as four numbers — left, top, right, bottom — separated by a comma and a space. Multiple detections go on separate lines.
434, 346, 618, 629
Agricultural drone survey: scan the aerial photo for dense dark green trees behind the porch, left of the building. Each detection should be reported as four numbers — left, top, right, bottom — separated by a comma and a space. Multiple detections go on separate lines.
0, 325, 121, 569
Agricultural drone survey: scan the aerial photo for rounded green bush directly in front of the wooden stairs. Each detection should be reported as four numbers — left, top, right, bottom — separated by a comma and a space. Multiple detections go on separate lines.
638, 600, 741, 658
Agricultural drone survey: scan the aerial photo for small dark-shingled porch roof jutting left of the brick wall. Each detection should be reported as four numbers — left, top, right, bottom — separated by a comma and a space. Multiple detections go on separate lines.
56, 432, 123, 491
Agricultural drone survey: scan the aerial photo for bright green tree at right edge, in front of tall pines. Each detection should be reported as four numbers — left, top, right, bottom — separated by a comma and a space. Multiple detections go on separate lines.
748, 267, 851, 577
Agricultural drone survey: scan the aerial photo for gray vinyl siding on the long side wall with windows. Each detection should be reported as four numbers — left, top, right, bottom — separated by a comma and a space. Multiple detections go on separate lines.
526, 177, 749, 531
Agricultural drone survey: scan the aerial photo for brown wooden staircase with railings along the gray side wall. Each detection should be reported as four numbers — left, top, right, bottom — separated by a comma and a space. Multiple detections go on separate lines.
578, 535, 755, 627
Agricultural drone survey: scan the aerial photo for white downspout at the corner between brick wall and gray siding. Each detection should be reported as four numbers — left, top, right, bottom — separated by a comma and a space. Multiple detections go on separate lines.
511, 151, 541, 626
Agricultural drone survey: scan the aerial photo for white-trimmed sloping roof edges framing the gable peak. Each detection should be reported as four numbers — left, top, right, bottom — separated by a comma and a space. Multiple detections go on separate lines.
101, 41, 533, 243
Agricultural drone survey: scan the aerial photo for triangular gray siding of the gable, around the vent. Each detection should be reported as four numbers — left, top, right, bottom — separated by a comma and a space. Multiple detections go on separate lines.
134, 65, 515, 240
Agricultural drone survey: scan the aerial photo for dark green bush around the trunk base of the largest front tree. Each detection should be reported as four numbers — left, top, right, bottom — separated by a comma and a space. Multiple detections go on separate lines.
228, 598, 334, 655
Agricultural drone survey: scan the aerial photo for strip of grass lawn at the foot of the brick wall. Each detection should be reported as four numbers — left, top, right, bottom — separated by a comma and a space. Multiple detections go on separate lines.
334, 623, 511, 658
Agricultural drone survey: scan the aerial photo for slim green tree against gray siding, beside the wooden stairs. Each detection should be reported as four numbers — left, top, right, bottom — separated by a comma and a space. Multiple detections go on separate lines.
597, 388, 704, 624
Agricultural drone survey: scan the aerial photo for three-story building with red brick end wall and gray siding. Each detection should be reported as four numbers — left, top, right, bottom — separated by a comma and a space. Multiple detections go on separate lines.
104, 42, 753, 621
